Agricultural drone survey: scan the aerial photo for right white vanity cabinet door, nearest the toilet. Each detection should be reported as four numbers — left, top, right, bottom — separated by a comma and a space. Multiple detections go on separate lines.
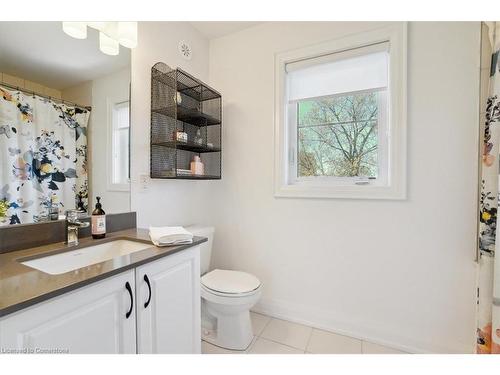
135, 247, 201, 353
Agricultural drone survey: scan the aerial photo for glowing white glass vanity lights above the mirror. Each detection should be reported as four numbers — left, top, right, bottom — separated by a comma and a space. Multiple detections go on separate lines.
62, 21, 137, 56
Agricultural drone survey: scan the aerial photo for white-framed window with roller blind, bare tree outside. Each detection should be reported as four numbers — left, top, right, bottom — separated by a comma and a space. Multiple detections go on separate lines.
275, 25, 406, 199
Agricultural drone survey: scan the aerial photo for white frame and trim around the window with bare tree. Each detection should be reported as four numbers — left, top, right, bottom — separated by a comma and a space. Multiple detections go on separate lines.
274, 22, 407, 199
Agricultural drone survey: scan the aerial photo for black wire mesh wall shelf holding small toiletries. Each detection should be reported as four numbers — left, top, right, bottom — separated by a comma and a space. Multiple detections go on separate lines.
150, 62, 222, 180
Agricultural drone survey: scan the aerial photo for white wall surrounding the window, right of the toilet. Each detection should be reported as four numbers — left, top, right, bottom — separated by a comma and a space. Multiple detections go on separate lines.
207, 22, 480, 352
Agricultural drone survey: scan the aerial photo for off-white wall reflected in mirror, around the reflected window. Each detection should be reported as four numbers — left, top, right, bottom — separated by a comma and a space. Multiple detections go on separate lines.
89, 68, 130, 213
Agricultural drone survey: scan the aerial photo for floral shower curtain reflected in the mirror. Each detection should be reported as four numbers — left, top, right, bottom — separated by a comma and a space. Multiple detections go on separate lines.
0, 85, 90, 225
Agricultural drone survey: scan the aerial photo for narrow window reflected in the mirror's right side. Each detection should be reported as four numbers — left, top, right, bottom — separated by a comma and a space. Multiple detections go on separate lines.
111, 101, 130, 190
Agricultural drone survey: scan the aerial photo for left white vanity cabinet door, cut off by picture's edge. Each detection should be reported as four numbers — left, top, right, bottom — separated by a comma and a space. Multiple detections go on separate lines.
0, 270, 136, 353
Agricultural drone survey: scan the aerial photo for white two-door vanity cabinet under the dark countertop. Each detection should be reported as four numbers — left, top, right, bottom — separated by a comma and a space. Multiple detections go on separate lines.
0, 246, 201, 354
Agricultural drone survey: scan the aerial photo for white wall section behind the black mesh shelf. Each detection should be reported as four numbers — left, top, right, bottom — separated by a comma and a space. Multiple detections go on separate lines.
131, 22, 217, 228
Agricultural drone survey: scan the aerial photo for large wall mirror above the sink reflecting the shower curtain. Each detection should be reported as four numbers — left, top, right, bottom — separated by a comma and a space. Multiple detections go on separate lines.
0, 22, 130, 225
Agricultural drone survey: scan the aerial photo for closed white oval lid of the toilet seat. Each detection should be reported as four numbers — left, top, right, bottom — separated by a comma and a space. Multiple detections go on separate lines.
201, 269, 260, 294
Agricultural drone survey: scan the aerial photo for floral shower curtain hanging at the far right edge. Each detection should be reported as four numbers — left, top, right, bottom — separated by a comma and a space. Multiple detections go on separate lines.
477, 22, 500, 354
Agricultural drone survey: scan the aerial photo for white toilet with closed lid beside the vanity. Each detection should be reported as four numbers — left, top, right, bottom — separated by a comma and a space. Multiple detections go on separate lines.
186, 226, 262, 350
